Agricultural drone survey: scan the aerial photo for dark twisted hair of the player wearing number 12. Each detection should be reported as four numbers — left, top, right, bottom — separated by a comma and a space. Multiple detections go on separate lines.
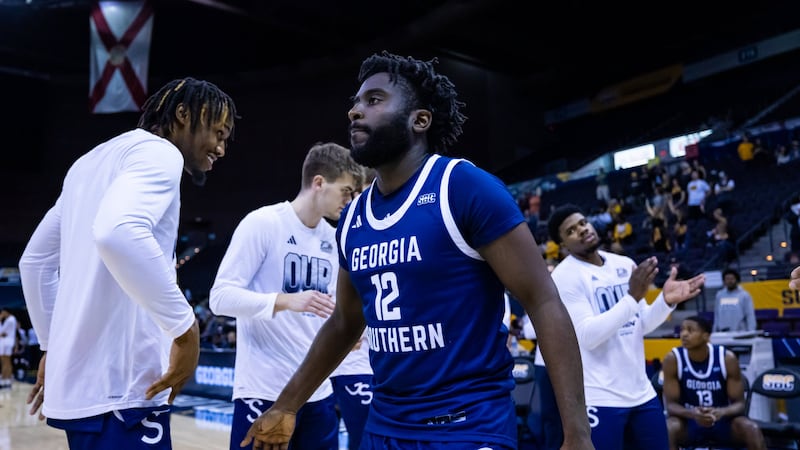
358, 50, 467, 153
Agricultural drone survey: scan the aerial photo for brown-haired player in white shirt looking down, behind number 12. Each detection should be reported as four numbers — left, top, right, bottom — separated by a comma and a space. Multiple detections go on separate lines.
209, 143, 363, 450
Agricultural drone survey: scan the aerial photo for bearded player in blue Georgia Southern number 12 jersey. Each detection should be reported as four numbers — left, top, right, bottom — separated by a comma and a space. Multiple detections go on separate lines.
242, 52, 592, 450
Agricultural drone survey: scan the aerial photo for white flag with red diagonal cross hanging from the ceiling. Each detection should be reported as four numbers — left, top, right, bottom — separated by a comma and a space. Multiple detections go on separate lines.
89, 0, 153, 113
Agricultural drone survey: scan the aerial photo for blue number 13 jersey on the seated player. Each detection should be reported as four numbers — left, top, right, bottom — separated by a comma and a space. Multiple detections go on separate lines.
672, 344, 730, 408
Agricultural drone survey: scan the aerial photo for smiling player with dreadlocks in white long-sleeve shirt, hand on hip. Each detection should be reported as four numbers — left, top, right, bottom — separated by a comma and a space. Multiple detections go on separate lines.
19, 78, 236, 450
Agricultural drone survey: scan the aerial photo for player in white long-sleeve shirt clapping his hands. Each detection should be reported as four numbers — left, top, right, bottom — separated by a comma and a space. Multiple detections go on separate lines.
548, 204, 705, 450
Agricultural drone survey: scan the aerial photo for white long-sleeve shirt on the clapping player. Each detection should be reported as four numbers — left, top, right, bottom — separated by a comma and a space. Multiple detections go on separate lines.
552, 251, 674, 408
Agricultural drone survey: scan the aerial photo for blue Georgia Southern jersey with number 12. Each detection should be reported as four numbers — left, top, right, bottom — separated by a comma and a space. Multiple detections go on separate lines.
337, 155, 524, 446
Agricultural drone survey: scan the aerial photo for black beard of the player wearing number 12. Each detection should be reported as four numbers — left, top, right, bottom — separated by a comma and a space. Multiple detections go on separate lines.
350, 113, 411, 168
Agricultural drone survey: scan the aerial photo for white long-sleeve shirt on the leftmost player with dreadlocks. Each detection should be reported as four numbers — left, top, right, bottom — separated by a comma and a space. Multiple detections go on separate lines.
19, 129, 194, 419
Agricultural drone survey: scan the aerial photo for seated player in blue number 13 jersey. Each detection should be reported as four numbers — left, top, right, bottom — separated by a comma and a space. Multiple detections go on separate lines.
662, 316, 766, 450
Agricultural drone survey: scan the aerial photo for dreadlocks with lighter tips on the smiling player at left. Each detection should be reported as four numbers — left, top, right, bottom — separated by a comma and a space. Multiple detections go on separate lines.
138, 77, 239, 138
